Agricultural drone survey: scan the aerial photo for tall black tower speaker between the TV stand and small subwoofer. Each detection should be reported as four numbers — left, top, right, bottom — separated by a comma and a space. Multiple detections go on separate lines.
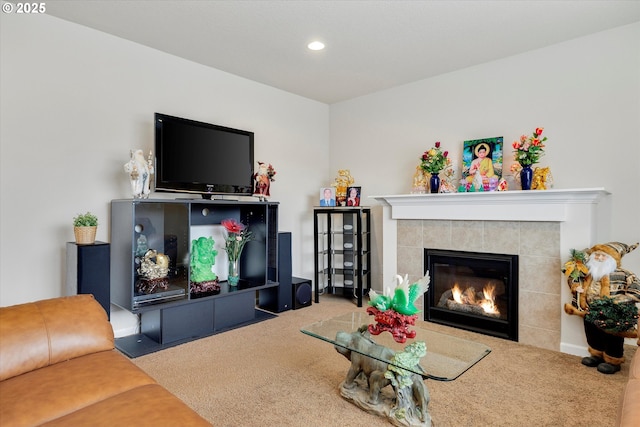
260, 231, 292, 313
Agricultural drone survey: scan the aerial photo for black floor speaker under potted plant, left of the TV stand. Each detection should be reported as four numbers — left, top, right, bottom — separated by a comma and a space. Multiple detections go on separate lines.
66, 242, 111, 316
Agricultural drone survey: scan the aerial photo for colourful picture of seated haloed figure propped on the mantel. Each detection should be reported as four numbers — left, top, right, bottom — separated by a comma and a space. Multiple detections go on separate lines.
459, 136, 503, 192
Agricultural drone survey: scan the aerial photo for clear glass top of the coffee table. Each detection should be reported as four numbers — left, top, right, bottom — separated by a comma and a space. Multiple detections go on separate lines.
301, 311, 491, 381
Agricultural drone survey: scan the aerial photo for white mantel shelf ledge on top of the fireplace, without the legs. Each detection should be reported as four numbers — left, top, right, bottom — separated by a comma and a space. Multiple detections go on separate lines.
371, 188, 610, 221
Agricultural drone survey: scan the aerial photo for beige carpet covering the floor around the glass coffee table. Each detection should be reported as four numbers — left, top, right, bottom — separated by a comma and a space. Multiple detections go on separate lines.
133, 296, 636, 427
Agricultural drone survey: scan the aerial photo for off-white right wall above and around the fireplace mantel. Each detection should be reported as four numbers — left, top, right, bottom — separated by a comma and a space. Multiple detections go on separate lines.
330, 23, 640, 289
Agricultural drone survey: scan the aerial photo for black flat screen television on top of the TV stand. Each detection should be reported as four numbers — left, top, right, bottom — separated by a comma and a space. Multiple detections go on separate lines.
155, 113, 254, 199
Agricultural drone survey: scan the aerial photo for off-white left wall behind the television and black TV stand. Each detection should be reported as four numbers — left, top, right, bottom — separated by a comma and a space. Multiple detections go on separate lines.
0, 14, 330, 306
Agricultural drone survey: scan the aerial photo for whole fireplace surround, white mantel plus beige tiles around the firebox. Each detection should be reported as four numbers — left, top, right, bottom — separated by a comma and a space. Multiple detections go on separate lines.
375, 188, 609, 355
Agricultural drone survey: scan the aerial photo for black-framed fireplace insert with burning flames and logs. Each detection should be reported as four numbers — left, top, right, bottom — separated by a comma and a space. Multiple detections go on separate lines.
424, 249, 518, 341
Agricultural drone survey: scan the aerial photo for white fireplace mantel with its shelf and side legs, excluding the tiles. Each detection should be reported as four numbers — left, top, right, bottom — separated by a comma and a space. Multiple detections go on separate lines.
371, 188, 611, 355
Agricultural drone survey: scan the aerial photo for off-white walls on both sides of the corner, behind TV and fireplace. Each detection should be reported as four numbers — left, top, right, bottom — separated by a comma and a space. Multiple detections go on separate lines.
0, 14, 640, 306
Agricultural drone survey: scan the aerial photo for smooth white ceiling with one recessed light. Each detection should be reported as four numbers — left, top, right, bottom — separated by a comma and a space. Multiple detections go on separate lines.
46, 0, 640, 104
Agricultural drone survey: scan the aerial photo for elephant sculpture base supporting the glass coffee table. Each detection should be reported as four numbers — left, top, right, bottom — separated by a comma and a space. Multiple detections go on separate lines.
334, 325, 431, 427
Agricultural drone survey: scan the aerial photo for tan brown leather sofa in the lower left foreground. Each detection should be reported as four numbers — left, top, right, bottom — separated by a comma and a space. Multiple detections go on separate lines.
0, 295, 211, 427
